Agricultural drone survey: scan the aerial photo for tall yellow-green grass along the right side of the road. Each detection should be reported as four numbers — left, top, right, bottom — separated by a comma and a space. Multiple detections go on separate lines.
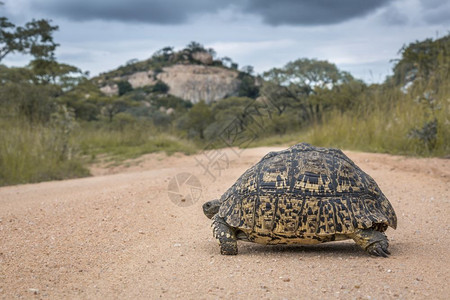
250, 78, 450, 157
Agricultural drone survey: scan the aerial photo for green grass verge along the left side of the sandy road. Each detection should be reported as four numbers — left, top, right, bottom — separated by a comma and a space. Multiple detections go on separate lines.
0, 119, 197, 186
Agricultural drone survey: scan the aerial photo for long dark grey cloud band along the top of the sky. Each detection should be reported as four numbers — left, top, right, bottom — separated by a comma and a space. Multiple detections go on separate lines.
32, 0, 393, 25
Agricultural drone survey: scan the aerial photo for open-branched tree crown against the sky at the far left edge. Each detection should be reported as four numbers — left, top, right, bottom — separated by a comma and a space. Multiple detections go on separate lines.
0, 17, 58, 61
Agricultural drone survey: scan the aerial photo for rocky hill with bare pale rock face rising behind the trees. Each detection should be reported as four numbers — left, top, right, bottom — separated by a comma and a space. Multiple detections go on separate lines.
94, 43, 254, 103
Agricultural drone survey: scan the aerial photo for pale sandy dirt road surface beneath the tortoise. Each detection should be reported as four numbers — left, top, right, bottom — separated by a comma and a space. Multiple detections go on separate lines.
0, 147, 450, 299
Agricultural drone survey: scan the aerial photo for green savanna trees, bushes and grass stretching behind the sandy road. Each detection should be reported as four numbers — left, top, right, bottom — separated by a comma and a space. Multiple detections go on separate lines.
0, 11, 450, 186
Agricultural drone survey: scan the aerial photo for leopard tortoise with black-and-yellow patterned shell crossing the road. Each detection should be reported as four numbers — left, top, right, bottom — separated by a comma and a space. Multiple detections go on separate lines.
203, 143, 397, 257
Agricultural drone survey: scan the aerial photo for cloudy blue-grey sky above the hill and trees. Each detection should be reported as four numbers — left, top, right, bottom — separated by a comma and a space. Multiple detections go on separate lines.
0, 0, 450, 83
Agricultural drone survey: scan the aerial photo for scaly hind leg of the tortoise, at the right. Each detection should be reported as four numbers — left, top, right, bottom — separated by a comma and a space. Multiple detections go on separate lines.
349, 229, 391, 257
